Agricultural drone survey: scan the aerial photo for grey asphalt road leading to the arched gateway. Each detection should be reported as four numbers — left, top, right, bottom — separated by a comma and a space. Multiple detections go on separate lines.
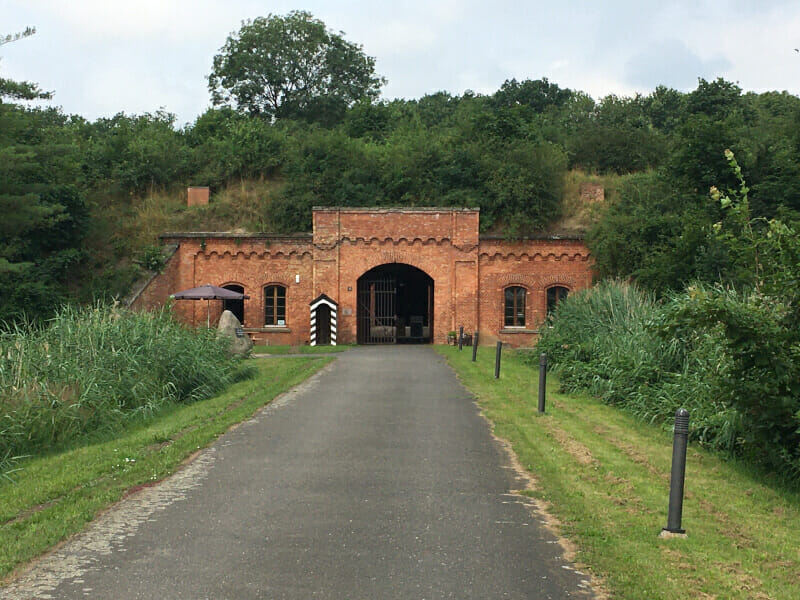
0, 346, 588, 600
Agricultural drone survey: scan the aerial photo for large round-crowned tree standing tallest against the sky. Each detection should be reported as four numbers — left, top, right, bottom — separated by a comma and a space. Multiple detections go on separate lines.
208, 11, 383, 123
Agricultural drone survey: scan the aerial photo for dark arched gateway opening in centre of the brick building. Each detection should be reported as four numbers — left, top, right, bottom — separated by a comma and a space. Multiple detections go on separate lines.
356, 263, 433, 344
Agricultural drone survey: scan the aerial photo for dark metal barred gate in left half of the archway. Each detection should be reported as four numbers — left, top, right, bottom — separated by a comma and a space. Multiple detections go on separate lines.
357, 279, 397, 344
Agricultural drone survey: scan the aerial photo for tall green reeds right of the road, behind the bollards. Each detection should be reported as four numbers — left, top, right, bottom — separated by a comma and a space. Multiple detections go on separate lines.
538, 281, 742, 451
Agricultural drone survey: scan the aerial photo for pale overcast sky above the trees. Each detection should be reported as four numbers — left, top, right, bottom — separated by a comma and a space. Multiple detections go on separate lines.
0, 0, 800, 124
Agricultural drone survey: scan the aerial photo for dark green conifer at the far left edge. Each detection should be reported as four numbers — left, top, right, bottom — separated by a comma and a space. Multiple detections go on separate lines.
0, 29, 88, 320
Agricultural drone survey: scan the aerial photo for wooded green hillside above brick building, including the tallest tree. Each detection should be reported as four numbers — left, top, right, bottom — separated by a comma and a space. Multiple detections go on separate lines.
0, 12, 800, 328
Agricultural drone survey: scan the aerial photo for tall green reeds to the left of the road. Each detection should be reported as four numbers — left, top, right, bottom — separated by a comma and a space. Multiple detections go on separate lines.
0, 306, 241, 471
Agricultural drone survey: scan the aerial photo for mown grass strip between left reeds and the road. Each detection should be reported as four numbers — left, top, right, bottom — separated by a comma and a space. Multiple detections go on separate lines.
0, 357, 331, 581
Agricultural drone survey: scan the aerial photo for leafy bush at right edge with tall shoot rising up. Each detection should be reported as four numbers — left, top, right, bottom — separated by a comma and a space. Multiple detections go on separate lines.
664, 150, 800, 482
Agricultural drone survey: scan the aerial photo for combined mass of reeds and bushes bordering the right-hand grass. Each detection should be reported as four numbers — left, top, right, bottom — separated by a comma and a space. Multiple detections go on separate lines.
538, 281, 800, 481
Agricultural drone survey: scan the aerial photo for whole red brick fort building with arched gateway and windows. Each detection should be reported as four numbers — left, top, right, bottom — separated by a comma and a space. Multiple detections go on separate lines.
133, 208, 592, 346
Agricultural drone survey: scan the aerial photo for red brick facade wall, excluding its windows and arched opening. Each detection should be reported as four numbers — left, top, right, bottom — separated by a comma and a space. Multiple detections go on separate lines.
134, 208, 592, 346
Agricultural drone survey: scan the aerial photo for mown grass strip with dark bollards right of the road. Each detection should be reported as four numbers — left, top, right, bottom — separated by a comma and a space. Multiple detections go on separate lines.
440, 347, 800, 600
